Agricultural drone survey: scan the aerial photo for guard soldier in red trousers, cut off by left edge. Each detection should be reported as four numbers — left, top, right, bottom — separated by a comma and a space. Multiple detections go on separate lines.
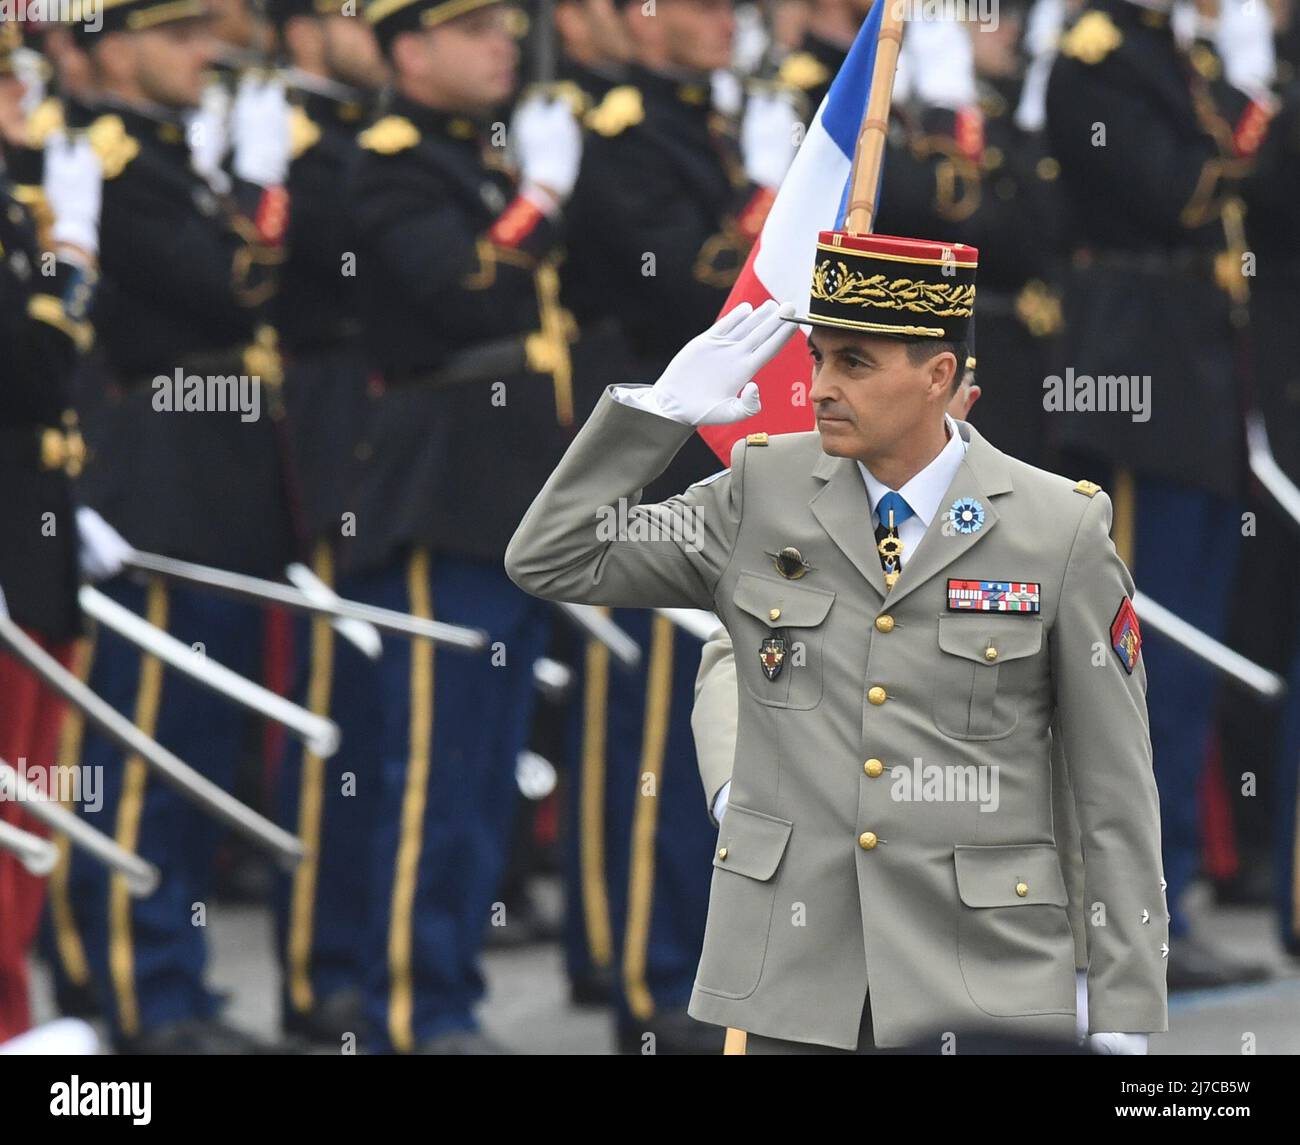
0, 19, 119, 1042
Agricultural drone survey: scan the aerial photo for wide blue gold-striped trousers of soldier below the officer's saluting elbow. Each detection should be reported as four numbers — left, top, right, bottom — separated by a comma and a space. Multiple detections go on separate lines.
351, 550, 550, 1053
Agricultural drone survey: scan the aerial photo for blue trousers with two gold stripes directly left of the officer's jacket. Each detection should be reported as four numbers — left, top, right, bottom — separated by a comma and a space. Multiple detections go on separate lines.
564, 610, 716, 1023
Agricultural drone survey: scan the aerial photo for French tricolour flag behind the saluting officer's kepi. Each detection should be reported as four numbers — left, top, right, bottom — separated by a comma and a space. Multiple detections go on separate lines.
699, 4, 885, 461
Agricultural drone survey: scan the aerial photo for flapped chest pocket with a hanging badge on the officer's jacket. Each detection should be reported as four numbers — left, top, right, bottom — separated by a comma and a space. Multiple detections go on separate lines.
732, 572, 835, 710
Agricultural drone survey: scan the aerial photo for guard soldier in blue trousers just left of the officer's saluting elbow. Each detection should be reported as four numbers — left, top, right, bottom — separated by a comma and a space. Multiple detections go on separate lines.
350, 0, 581, 1053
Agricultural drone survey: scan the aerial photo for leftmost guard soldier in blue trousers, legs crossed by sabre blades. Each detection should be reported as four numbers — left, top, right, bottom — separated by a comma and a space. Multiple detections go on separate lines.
72, 0, 290, 1053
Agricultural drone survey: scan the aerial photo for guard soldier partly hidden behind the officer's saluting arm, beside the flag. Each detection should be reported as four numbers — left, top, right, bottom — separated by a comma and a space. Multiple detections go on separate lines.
566, 0, 798, 1053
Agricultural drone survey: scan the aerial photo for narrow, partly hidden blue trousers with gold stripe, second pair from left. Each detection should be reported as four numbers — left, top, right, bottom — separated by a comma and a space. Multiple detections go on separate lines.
276, 542, 379, 1014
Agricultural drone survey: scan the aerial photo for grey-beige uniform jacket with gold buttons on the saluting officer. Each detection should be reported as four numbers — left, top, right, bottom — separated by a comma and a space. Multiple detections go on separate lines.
506, 394, 1167, 1049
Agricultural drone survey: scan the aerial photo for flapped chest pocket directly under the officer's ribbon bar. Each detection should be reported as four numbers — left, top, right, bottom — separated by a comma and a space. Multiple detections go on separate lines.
935, 613, 1043, 740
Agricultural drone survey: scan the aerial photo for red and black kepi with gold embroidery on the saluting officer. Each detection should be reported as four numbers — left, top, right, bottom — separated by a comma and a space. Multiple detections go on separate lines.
794, 230, 979, 342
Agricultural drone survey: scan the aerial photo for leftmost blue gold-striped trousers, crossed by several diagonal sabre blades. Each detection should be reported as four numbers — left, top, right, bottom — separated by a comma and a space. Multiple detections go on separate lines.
65, 577, 263, 1037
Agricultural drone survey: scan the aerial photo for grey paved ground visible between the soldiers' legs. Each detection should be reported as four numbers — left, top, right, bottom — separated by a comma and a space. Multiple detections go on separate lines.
30, 885, 1300, 1054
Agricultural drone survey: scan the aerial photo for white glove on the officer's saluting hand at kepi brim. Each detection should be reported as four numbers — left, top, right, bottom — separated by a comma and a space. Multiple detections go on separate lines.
642, 299, 798, 425
